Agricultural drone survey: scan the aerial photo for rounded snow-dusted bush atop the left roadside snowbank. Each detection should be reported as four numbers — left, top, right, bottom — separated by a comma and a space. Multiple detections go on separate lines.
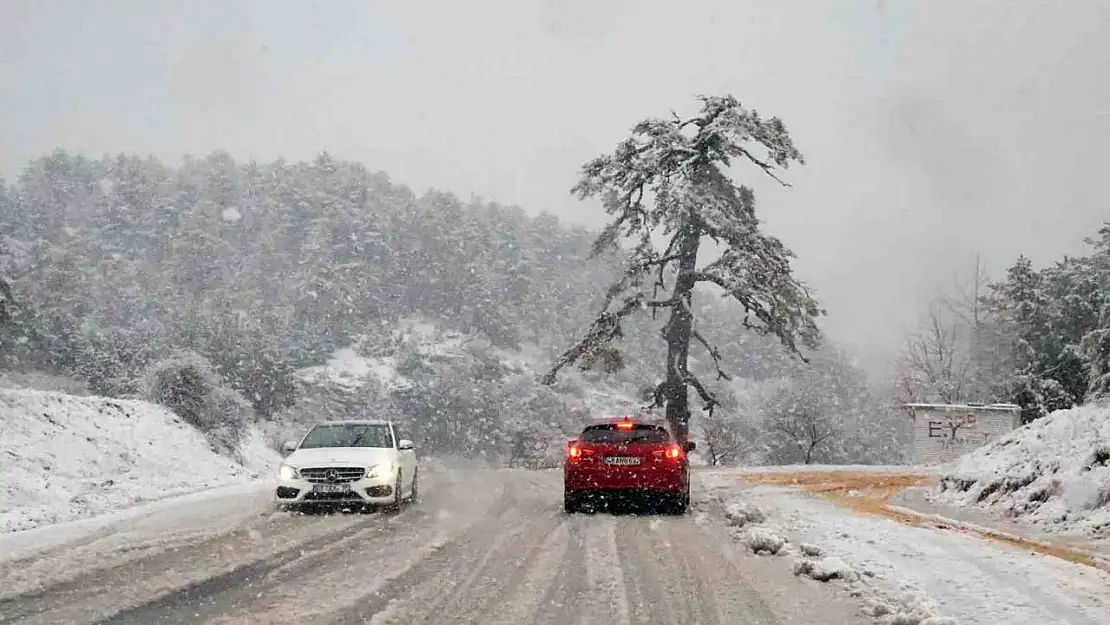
143, 352, 252, 458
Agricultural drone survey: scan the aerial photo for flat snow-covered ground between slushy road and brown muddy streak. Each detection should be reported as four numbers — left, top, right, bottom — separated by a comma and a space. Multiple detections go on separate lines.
700, 467, 1110, 625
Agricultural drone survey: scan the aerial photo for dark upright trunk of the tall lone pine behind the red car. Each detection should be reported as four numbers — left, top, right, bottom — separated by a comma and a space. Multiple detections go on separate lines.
664, 225, 702, 444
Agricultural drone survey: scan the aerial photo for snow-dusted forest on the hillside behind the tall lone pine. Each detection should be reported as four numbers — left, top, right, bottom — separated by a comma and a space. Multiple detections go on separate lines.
0, 151, 919, 463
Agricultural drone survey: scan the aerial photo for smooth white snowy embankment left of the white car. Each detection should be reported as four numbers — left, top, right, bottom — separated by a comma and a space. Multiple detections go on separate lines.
0, 389, 278, 532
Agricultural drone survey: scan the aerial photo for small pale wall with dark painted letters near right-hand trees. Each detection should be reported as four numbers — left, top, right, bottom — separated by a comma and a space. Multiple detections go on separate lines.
905, 404, 1021, 464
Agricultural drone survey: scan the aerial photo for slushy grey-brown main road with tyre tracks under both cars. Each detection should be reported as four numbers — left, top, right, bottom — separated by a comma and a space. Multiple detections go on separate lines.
0, 471, 871, 625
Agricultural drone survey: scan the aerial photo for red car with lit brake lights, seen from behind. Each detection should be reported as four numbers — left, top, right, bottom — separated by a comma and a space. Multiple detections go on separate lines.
563, 416, 695, 514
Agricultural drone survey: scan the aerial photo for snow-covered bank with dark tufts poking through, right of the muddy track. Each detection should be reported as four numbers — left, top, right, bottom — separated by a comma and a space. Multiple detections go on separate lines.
934, 404, 1110, 537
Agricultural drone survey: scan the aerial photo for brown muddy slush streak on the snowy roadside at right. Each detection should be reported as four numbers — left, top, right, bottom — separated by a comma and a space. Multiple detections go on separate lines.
744, 471, 1110, 573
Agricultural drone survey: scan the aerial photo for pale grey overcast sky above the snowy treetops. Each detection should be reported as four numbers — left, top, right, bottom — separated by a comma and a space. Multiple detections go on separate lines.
0, 0, 1110, 370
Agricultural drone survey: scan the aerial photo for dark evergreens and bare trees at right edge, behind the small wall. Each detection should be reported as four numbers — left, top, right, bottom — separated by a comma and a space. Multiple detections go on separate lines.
897, 222, 1110, 422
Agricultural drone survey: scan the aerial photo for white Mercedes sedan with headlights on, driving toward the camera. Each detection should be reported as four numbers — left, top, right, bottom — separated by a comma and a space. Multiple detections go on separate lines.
275, 421, 420, 508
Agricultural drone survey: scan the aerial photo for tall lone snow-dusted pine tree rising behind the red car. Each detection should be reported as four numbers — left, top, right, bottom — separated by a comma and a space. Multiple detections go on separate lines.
544, 95, 824, 442
